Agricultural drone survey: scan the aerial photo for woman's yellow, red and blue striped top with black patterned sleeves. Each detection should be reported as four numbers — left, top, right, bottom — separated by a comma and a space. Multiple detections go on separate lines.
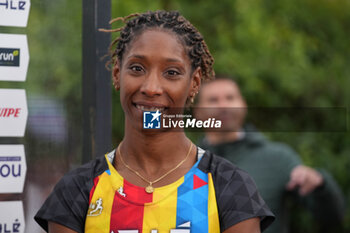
35, 148, 273, 233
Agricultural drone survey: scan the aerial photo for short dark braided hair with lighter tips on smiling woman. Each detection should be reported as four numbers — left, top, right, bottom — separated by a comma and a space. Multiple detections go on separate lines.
101, 10, 215, 80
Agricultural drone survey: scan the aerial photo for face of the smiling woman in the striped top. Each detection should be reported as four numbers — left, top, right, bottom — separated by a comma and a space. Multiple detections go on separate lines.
113, 29, 201, 128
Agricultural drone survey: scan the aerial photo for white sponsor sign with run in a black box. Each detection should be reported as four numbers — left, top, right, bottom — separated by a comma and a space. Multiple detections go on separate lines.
0, 33, 29, 81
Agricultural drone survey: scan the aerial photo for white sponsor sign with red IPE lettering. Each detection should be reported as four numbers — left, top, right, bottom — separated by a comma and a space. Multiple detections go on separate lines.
0, 89, 28, 137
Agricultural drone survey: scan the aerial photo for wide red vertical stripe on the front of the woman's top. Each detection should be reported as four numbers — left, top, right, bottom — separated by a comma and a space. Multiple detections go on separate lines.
110, 180, 153, 232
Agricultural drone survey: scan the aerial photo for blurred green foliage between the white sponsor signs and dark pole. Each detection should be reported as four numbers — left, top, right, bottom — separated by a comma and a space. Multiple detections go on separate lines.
27, 0, 82, 104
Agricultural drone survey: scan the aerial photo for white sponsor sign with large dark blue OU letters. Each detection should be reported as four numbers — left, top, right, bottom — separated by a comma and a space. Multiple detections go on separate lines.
0, 145, 27, 193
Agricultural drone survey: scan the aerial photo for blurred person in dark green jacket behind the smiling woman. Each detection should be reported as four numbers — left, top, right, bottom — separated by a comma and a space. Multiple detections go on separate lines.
195, 76, 345, 233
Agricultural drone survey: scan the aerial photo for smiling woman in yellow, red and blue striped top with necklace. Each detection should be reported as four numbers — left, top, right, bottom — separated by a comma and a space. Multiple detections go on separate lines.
35, 11, 273, 233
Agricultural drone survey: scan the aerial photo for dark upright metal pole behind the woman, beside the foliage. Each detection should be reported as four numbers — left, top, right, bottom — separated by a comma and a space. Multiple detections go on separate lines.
82, 0, 112, 162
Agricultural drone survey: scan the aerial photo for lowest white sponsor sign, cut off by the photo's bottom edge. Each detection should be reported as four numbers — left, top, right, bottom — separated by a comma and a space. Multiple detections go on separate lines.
0, 201, 25, 233
